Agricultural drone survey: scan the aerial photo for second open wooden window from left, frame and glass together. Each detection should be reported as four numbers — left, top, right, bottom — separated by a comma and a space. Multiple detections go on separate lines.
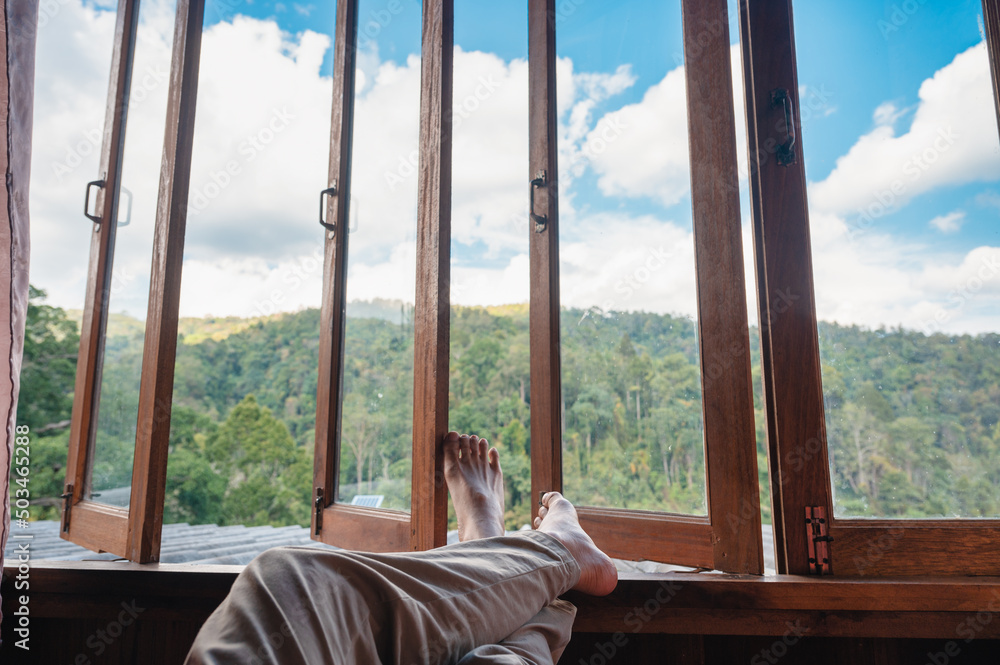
312, 0, 453, 551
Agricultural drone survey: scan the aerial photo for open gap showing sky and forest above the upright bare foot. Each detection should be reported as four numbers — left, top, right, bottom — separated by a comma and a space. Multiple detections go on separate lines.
449, 0, 532, 529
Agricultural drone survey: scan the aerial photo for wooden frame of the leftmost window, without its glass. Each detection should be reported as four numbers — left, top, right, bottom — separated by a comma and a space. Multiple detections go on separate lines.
60, 0, 205, 563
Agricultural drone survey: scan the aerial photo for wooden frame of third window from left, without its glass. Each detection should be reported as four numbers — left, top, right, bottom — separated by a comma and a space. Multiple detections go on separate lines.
528, 0, 764, 574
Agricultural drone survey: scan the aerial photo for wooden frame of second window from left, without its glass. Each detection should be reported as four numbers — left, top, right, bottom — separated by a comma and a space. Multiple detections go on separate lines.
312, 0, 454, 551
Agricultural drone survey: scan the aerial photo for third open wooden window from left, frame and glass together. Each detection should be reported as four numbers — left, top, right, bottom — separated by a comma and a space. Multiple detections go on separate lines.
529, 0, 763, 574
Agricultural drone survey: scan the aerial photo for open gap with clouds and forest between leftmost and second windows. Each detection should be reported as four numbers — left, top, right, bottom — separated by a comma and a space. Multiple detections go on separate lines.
162, 0, 335, 532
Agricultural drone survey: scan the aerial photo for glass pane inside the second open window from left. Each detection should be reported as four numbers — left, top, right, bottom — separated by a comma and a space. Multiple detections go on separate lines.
337, 0, 421, 510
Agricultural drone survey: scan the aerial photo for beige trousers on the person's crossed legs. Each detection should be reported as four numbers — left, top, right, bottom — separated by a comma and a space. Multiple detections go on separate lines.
187, 531, 580, 665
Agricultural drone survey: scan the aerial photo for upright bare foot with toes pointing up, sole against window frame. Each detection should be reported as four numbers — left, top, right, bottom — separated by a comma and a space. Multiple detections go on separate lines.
444, 432, 504, 541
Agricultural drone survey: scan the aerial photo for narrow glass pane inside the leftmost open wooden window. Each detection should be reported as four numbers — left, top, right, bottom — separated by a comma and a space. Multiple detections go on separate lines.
88, 0, 176, 506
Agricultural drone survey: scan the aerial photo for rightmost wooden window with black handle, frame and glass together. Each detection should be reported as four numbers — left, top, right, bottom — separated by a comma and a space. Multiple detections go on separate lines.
740, 0, 1000, 575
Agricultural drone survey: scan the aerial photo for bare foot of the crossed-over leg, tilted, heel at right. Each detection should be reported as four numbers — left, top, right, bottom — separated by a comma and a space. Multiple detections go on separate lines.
535, 492, 618, 596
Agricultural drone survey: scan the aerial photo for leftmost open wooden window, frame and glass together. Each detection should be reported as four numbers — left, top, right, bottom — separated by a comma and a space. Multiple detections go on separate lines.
62, 0, 204, 563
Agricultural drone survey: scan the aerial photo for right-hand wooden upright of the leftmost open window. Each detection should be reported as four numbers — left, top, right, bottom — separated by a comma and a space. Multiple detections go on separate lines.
126, 0, 205, 563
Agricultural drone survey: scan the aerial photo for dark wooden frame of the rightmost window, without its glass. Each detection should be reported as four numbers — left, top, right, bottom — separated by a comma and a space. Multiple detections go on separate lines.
740, 0, 1000, 576
